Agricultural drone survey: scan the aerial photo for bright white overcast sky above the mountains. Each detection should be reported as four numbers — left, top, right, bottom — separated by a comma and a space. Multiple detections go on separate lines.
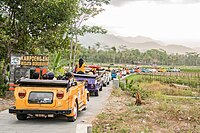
87, 0, 200, 47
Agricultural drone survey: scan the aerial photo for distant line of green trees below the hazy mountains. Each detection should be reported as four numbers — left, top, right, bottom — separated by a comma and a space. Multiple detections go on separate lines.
80, 46, 200, 66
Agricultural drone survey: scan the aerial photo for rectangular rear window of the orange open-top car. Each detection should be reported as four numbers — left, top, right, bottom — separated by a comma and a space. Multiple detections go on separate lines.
28, 92, 53, 104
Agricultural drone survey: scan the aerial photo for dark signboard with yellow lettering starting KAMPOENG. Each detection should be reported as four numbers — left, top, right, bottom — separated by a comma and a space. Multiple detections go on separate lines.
20, 55, 49, 66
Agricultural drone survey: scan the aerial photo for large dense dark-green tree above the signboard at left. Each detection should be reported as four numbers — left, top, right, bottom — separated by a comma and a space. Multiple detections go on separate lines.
0, 0, 77, 83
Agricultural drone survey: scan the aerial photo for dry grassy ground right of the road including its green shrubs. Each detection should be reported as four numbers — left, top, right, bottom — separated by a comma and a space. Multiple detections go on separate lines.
93, 75, 200, 133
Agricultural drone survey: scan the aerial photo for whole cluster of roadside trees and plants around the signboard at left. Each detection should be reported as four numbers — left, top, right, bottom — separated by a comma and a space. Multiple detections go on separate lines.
0, 0, 110, 97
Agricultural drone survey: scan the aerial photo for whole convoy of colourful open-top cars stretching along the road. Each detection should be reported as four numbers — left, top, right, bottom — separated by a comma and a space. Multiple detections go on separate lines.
9, 66, 180, 122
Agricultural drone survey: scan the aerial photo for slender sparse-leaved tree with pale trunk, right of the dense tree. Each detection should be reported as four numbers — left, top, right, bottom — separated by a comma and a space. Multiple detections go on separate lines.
70, 0, 110, 67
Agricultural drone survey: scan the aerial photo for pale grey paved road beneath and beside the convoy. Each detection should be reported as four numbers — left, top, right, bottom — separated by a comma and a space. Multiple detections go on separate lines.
0, 81, 112, 133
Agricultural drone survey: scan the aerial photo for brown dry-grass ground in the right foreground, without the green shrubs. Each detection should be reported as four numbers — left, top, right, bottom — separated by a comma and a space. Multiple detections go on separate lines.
93, 85, 200, 133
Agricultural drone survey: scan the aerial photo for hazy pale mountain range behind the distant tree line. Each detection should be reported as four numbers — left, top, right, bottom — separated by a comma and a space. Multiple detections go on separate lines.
79, 34, 200, 54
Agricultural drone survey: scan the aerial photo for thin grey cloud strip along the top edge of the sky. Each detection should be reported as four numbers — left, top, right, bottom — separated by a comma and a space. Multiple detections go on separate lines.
111, 0, 200, 6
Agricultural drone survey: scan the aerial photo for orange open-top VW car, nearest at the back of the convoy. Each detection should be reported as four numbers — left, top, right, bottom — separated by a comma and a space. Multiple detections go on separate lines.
9, 79, 89, 122
